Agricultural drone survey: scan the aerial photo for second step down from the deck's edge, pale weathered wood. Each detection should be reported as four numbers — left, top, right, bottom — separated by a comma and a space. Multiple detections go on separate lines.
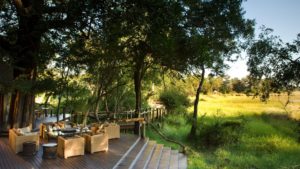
130, 141, 156, 169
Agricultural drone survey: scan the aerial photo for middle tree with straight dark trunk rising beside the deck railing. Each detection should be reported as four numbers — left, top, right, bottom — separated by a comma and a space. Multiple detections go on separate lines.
108, 0, 186, 133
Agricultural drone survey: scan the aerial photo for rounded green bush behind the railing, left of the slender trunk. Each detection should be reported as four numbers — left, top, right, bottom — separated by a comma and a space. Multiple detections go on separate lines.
159, 89, 190, 113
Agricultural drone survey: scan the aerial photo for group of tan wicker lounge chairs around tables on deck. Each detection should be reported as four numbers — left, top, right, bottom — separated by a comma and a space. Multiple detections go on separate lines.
9, 122, 120, 159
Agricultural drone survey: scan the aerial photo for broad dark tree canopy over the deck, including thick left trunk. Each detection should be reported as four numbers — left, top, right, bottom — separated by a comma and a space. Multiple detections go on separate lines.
0, 0, 253, 134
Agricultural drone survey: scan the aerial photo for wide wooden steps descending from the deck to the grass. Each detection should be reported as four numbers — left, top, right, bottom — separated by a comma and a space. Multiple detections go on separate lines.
113, 138, 187, 169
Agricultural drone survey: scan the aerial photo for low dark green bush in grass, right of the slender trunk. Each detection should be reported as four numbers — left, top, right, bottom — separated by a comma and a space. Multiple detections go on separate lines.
199, 120, 243, 147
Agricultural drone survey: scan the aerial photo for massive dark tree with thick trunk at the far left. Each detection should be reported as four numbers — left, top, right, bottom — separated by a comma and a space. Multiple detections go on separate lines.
0, 0, 103, 128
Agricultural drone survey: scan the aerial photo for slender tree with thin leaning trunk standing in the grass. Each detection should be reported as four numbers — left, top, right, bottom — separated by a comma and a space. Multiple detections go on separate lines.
184, 0, 253, 137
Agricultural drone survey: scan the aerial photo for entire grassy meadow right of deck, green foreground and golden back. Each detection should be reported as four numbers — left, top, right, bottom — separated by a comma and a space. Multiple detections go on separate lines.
147, 92, 300, 169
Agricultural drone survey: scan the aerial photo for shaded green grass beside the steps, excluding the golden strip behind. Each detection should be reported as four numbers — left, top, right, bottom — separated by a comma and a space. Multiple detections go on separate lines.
147, 94, 300, 169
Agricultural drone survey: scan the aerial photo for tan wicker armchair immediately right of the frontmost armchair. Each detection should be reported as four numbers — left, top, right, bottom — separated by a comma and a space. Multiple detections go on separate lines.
83, 133, 108, 154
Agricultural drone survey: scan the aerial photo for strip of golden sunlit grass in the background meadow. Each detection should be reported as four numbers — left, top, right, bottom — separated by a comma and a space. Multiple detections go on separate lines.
188, 92, 300, 119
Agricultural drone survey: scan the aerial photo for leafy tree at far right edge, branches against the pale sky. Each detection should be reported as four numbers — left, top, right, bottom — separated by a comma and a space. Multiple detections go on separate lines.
247, 27, 300, 101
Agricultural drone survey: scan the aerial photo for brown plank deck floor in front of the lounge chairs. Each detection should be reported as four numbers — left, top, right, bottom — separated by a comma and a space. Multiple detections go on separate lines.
0, 134, 138, 169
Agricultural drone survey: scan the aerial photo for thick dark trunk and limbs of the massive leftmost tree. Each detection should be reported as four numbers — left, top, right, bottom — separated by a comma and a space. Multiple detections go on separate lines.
0, 0, 90, 129
